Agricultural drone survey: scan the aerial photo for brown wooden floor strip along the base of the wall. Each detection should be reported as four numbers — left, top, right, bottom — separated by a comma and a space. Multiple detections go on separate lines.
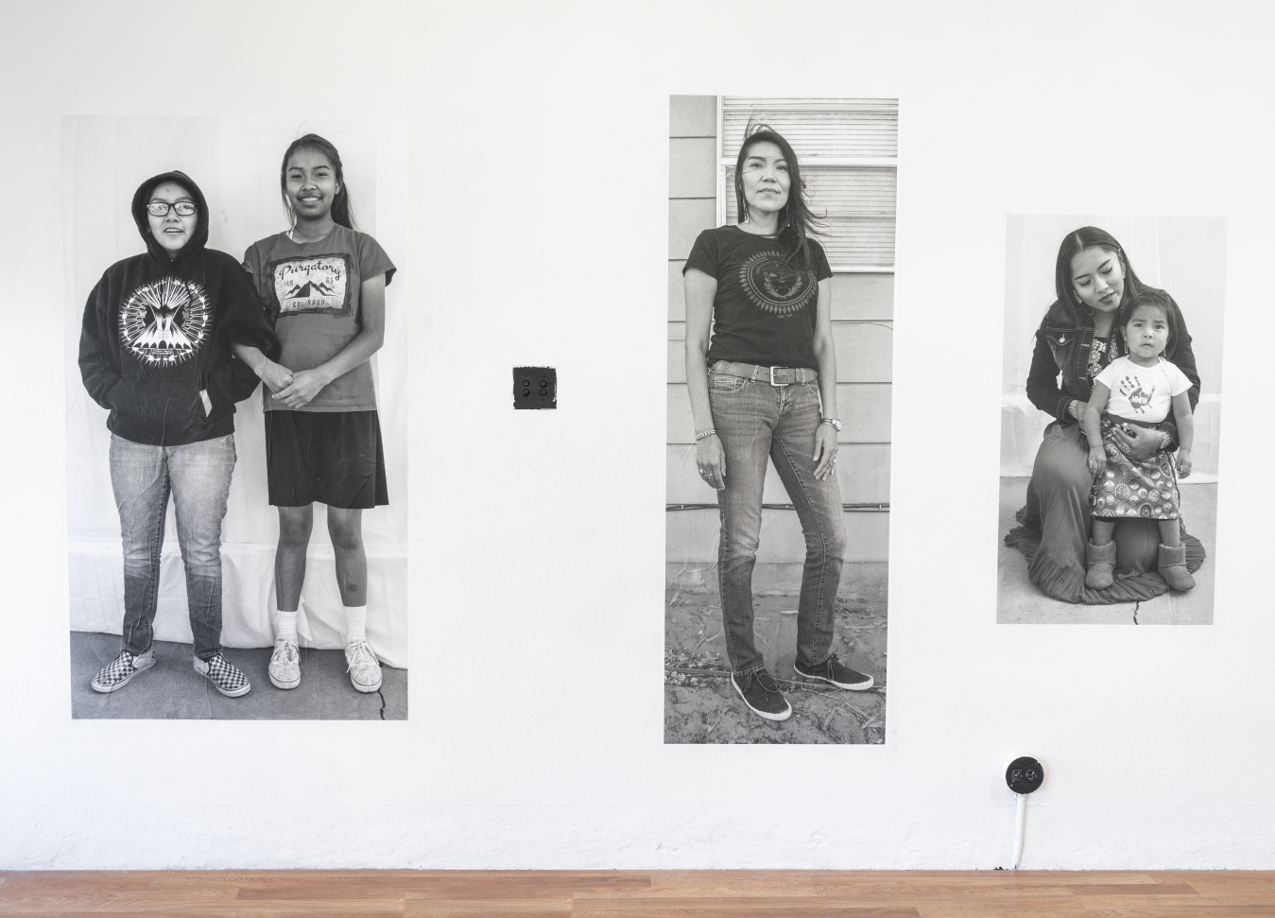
0, 871, 1275, 918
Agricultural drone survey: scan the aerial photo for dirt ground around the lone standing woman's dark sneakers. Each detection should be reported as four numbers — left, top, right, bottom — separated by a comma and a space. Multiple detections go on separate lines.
664, 588, 886, 743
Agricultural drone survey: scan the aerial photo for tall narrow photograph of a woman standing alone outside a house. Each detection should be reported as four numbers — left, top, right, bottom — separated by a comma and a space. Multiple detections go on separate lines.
664, 96, 899, 743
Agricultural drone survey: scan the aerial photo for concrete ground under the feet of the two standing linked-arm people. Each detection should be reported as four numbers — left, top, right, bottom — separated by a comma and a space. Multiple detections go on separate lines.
71, 631, 407, 720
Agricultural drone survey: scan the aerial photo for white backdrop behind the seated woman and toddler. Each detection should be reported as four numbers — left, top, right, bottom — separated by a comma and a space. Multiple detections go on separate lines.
1001, 214, 1227, 482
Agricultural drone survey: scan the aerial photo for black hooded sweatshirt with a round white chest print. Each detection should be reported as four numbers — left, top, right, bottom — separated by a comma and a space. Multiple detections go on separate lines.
79, 172, 279, 446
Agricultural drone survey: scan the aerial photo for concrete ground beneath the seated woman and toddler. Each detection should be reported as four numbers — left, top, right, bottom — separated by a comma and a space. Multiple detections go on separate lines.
996, 478, 1218, 625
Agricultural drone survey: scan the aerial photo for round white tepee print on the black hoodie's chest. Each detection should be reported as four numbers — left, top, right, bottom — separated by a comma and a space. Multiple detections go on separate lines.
120, 277, 213, 367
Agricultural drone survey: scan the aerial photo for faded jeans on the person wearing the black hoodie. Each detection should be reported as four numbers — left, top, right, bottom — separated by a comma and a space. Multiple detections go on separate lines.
111, 434, 235, 659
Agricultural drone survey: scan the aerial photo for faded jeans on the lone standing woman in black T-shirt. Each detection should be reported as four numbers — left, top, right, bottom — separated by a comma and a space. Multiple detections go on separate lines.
709, 364, 847, 673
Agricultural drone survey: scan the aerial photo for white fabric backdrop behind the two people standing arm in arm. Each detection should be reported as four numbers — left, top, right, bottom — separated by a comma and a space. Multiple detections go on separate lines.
62, 116, 411, 667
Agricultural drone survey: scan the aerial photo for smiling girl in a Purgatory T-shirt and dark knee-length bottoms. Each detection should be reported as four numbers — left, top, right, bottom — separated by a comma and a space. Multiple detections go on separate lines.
235, 134, 395, 692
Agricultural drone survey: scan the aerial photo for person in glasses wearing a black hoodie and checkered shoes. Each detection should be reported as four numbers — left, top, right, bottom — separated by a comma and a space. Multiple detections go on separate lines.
79, 172, 279, 697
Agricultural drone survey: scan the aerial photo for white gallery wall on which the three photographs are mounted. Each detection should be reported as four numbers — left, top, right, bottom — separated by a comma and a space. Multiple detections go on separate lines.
0, 0, 1275, 870
